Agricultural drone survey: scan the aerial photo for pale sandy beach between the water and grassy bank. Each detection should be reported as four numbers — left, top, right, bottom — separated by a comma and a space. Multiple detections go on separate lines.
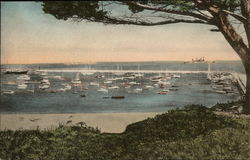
0, 112, 164, 133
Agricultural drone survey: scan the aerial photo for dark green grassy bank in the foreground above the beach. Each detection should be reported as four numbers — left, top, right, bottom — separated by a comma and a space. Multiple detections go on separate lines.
0, 105, 250, 160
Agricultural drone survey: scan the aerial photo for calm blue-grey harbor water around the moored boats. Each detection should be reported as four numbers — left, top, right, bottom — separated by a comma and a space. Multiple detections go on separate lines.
0, 61, 244, 113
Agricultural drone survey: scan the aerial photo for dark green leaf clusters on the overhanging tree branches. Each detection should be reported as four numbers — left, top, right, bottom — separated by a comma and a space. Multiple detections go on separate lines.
42, 0, 240, 21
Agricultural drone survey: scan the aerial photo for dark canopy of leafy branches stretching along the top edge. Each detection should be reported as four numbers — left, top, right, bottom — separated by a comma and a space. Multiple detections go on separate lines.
42, 0, 246, 25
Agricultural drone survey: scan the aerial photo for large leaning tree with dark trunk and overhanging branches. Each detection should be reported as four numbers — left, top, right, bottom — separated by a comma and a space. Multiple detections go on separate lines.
42, 0, 250, 114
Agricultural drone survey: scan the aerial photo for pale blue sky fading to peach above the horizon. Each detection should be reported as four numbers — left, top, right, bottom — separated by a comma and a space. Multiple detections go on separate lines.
1, 2, 239, 64
